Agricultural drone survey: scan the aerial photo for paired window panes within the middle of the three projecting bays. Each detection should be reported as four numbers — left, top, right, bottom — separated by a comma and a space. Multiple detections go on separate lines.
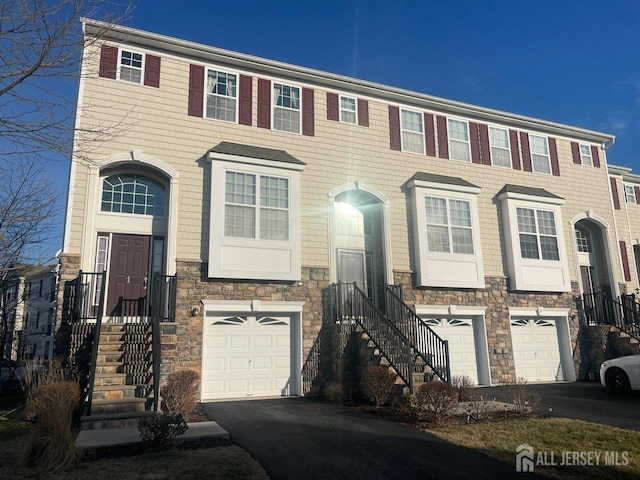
424, 196, 473, 255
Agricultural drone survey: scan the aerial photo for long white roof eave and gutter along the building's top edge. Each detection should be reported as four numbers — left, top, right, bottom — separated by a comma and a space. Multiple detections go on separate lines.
81, 18, 615, 143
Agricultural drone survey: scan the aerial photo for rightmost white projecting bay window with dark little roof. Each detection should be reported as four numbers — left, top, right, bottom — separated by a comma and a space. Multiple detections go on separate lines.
498, 185, 578, 292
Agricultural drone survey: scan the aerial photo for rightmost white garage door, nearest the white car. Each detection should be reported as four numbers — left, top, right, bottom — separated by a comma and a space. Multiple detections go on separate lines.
511, 318, 564, 381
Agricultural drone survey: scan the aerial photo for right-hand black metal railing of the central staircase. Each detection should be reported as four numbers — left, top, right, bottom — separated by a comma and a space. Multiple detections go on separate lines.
385, 285, 451, 383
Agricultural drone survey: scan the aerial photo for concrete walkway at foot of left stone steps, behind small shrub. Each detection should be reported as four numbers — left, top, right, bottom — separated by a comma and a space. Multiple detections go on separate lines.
76, 422, 229, 450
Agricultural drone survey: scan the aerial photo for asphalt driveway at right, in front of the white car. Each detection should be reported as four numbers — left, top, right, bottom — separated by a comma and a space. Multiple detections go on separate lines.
479, 382, 640, 431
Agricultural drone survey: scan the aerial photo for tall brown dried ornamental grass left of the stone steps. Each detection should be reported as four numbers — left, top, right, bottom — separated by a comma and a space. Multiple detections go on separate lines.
26, 381, 80, 470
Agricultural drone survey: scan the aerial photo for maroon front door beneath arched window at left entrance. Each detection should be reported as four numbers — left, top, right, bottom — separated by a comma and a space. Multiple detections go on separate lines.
106, 234, 150, 316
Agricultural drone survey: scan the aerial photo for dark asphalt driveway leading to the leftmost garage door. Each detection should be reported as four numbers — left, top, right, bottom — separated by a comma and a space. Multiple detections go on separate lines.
204, 398, 536, 480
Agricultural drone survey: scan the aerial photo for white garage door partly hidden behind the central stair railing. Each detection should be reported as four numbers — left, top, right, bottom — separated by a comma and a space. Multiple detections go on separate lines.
424, 318, 478, 385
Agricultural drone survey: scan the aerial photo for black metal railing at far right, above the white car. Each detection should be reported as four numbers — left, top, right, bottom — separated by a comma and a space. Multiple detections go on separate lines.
578, 293, 640, 341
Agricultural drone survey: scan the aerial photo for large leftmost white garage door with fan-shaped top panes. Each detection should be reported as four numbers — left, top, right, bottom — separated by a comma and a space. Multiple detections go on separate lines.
202, 315, 295, 400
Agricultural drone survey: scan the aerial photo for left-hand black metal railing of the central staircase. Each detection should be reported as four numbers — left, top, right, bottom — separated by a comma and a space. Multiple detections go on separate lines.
329, 283, 414, 392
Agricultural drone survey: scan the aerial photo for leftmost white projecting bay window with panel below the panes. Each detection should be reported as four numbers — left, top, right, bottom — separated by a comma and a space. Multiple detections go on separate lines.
209, 149, 304, 280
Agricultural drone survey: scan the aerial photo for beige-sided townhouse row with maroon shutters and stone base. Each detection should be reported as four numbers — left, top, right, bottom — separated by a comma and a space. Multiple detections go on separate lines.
60, 20, 640, 406
